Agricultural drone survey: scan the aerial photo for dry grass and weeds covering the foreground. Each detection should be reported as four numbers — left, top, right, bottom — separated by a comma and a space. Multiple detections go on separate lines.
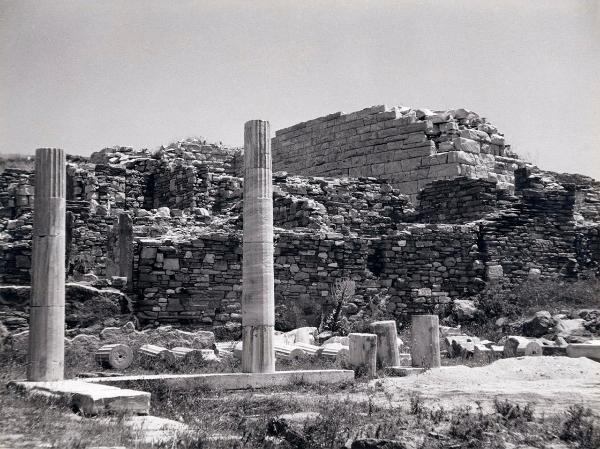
0, 344, 600, 449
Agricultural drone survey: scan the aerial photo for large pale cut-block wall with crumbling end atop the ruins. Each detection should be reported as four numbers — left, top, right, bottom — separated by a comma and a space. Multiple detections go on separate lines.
272, 106, 519, 200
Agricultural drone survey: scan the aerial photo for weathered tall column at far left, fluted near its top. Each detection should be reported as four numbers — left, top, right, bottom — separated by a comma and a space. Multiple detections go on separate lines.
27, 148, 66, 381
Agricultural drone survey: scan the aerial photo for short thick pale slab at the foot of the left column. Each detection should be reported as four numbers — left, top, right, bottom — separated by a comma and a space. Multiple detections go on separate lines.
9, 380, 150, 415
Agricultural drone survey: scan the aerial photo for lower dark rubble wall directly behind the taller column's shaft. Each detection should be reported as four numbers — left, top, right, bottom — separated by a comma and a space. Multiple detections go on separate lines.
134, 225, 479, 326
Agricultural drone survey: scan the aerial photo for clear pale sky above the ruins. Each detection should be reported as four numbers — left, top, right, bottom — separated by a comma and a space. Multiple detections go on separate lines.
0, 0, 600, 179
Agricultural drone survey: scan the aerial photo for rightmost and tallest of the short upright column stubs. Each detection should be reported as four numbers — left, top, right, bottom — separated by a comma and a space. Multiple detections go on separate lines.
410, 315, 441, 368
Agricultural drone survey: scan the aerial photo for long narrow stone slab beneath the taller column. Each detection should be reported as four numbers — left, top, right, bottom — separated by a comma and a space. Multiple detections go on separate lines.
86, 369, 354, 390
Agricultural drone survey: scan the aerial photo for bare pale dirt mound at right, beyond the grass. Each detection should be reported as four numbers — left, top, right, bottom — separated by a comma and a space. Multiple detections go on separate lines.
370, 357, 600, 415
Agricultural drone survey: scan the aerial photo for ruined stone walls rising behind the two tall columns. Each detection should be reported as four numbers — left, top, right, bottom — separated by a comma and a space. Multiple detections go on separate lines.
0, 106, 600, 336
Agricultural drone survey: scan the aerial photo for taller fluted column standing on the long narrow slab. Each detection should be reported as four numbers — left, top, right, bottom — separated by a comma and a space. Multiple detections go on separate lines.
242, 120, 275, 373
